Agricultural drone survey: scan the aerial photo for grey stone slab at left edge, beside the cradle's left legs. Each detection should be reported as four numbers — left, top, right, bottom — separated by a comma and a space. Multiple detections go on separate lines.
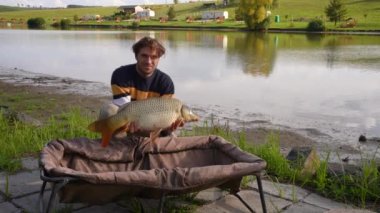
0, 170, 42, 197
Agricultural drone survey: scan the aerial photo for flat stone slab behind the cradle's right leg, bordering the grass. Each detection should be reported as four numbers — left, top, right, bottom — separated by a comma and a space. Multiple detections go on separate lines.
249, 180, 311, 202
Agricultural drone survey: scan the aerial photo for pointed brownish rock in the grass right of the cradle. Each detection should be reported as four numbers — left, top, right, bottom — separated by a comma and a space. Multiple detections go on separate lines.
286, 147, 320, 175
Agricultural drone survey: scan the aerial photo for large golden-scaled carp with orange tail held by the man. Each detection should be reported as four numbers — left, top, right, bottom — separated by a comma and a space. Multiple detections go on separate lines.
88, 98, 199, 147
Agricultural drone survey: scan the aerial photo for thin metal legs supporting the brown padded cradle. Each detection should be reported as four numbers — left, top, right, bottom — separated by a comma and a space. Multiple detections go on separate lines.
38, 168, 267, 213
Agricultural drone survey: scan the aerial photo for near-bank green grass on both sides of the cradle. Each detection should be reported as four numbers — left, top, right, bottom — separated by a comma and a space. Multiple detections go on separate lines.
0, 109, 380, 209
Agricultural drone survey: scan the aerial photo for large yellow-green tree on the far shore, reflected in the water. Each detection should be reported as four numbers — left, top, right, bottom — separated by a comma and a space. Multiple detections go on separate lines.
236, 0, 273, 30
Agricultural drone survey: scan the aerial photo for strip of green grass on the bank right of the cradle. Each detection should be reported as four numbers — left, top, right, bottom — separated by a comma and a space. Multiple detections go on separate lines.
182, 120, 380, 210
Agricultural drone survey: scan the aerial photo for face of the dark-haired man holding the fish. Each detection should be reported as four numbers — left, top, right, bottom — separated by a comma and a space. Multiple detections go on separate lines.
136, 47, 160, 78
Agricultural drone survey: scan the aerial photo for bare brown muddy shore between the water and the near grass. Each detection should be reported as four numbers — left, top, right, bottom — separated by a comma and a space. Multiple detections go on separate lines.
0, 67, 372, 163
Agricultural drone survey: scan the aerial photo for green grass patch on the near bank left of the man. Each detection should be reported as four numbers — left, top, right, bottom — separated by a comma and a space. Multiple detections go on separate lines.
0, 109, 99, 172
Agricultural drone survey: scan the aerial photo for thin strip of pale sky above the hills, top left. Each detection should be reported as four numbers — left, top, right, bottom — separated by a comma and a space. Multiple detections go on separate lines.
0, 0, 185, 7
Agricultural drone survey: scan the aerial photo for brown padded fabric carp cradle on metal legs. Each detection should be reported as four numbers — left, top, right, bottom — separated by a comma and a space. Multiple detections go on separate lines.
39, 136, 266, 212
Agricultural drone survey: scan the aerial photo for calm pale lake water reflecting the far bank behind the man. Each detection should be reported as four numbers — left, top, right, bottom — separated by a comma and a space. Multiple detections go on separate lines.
0, 30, 380, 150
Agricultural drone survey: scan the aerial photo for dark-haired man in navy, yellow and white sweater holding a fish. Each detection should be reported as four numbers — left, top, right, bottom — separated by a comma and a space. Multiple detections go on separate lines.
99, 37, 174, 134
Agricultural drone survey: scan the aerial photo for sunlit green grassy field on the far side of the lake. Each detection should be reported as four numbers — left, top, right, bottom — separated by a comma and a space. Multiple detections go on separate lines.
0, 0, 380, 31
